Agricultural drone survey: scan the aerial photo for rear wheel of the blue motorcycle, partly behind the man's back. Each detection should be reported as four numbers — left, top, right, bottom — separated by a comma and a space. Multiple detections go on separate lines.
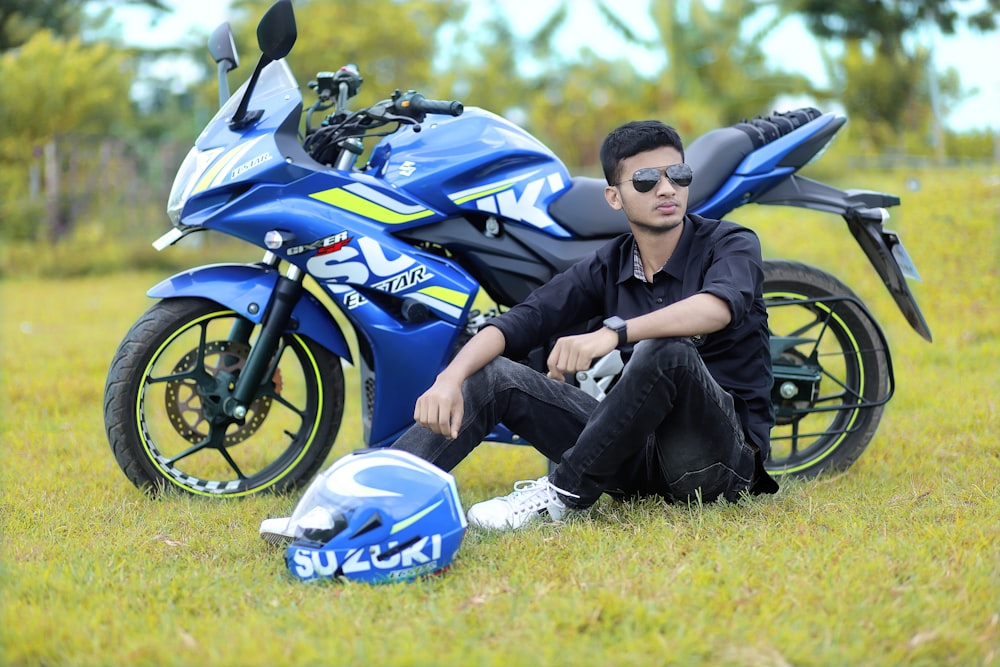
764, 260, 892, 477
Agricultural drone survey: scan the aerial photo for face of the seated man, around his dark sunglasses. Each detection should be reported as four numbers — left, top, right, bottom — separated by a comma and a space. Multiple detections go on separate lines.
604, 146, 688, 233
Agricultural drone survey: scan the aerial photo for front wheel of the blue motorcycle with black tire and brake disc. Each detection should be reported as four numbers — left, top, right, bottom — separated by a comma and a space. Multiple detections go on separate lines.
104, 298, 344, 497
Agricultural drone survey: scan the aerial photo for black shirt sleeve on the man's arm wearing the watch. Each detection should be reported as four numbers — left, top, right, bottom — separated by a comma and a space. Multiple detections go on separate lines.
700, 225, 764, 326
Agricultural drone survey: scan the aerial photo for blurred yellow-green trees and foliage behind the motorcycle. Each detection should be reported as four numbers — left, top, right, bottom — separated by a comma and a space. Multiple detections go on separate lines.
0, 0, 1000, 258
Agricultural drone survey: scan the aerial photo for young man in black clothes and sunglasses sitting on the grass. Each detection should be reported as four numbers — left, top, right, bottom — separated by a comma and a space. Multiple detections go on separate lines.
393, 121, 778, 530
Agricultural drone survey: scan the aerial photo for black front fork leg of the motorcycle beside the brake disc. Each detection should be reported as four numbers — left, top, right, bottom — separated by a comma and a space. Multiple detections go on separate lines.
223, 252, 305, 420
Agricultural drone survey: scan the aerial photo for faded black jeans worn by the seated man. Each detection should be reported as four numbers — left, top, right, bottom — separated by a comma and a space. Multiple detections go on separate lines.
393, 338, 755, 508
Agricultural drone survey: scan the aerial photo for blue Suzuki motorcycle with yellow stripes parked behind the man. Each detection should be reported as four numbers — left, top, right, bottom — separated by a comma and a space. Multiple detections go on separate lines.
104, 0, 931, 497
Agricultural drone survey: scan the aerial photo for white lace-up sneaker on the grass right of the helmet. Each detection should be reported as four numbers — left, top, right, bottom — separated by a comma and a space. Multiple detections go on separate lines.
469, 477, 577, 530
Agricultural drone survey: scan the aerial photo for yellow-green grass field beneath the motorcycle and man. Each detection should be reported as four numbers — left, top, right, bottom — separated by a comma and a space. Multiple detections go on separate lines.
0, 172, 1000, 667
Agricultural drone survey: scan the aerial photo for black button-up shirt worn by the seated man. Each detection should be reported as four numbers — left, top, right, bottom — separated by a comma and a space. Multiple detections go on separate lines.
490, 214, 774, 459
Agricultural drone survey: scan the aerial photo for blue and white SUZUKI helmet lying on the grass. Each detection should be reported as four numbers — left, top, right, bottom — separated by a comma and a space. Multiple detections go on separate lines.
261, 449, 467, 583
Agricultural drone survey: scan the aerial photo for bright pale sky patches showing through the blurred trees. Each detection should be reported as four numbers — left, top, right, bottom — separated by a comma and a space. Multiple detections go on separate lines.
114, 0, 1000, 131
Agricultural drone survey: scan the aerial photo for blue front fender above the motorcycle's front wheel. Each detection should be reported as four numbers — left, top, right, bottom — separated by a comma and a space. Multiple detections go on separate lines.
146, 264, 353, 363
